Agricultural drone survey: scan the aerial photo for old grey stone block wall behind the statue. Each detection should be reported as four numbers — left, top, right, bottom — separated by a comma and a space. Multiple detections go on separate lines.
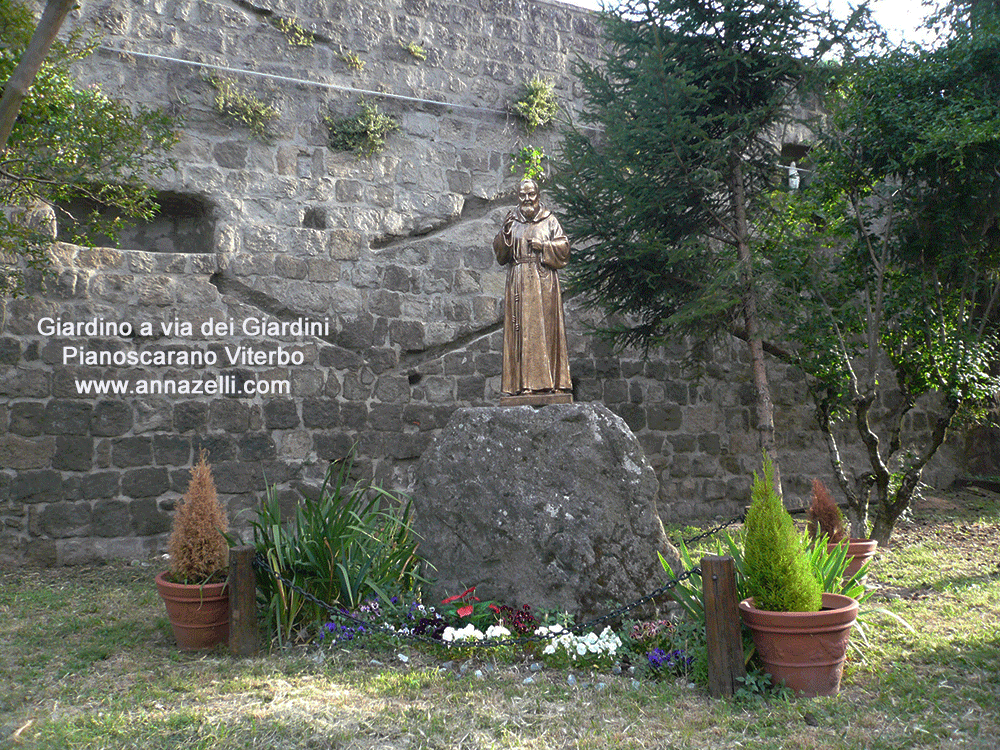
0, 0, 959, 565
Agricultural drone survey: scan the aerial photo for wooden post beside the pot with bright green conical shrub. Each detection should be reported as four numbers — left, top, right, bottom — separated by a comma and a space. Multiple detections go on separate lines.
701, 555, 746, 698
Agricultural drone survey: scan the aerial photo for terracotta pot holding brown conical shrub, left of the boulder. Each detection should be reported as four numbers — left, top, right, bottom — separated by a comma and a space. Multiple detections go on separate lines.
156, 572, 229, 651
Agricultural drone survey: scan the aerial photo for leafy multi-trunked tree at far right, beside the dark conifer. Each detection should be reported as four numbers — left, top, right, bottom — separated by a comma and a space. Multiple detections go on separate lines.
765, 2, 1000, 543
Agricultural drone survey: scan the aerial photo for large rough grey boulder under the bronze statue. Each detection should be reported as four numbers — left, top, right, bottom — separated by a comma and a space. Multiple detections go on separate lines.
413, 403, 680, 621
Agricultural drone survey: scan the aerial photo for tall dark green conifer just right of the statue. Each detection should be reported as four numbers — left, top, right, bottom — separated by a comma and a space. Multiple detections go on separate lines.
553, 0, 862, 491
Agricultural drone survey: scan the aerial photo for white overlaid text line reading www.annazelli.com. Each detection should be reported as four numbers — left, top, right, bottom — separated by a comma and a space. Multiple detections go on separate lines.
74, 375, 292, 396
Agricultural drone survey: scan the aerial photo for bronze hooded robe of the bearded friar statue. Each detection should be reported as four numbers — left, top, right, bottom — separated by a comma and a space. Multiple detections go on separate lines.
493, 207, 573, 395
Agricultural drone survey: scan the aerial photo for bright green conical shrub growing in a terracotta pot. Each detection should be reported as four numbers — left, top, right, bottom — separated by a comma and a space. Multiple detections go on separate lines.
743, 454, 823, 612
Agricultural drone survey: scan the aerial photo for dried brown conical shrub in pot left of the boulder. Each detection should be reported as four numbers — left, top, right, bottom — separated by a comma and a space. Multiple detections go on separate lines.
169, 449, 229, 583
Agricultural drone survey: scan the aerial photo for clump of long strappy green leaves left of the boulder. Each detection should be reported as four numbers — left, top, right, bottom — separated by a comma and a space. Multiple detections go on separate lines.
252, 453, 424, 644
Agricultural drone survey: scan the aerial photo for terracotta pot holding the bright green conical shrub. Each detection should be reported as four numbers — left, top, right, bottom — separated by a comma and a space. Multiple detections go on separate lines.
740, 594, 858, 697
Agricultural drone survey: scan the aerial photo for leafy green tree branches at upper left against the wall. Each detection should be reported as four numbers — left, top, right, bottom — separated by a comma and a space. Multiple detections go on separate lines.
0, 0, 176, 295
